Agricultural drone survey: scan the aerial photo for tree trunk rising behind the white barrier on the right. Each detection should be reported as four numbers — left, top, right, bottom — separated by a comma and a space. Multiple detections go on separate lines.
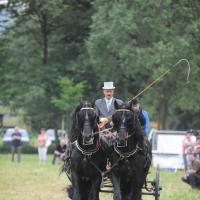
158, 96, 168, 130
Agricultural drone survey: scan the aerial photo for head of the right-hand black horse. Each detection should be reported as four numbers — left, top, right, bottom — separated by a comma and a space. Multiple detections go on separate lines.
112, 100, 135, 147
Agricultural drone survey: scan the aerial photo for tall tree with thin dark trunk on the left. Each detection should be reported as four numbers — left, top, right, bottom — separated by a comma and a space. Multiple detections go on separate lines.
2, 0, 95, 139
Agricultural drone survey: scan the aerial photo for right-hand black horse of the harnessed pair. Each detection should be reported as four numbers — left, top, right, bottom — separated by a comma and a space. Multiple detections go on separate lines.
109, 101, 152, 200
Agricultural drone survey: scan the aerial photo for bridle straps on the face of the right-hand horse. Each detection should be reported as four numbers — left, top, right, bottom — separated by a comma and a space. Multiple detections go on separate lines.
116, 109, 135, 147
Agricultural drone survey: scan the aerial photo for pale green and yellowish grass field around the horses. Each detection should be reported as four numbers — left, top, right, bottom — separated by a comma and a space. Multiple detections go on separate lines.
0, 154, 200, 200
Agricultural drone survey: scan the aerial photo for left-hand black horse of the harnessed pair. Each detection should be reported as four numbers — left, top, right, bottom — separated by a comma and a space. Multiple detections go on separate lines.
65, 98, 109, 200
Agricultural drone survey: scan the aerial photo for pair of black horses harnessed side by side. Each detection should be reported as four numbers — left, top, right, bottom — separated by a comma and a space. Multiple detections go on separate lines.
63, 98, 151, 200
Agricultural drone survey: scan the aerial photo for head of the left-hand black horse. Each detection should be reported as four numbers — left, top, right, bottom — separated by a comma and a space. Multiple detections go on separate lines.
76, 97, 96, 145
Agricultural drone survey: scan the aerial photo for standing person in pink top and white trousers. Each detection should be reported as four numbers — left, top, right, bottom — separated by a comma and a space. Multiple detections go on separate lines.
37, 128, 48, 165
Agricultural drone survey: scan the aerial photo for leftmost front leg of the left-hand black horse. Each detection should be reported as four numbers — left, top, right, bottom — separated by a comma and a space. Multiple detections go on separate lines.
71, 171, 83, 200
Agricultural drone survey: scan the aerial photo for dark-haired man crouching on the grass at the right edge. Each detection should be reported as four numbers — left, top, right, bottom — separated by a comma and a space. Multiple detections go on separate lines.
182, 154, 200, 189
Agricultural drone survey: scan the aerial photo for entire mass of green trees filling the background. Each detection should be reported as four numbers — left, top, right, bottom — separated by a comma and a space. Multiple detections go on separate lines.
0, 0, 200, 130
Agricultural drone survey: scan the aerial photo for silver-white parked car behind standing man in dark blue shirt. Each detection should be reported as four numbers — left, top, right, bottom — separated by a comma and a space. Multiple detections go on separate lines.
3, 128, 32, 145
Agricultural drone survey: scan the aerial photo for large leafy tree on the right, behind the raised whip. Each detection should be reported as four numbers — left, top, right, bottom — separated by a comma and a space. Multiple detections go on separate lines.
87, 0, 200, 129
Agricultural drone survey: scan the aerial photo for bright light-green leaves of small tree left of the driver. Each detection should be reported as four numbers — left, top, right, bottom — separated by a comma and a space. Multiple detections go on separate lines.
52, 77, 85, 111
